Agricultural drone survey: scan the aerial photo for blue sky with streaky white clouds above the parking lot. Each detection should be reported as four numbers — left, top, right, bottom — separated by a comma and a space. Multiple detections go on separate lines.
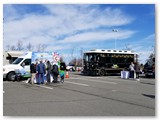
3, 4, 156, 63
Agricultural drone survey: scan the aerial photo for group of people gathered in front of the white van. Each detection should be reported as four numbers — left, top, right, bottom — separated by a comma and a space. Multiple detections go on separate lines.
30, 60, 66, 85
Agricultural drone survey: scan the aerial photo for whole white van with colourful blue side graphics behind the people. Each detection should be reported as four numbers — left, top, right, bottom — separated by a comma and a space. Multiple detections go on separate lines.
3, 52, 60, 80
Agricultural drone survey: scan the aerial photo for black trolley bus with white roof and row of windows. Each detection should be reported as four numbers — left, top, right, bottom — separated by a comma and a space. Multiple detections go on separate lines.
83, 49, 137, 76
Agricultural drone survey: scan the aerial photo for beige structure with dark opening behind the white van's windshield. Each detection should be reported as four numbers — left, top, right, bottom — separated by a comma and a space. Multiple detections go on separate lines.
3, 51, 24, 65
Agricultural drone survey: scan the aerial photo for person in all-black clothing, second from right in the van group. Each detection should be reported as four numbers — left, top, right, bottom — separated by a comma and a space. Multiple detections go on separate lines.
52, 64, 59, 83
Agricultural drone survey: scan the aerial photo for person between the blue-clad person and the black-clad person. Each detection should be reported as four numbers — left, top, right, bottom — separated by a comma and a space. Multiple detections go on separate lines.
46, 60, 52, 83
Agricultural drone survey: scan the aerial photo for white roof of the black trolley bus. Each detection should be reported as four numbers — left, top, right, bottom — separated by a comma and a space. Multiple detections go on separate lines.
84, 49, 136, 54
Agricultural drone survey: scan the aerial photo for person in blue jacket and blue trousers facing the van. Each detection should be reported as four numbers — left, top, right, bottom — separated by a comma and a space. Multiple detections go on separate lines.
36, 60, 46, 85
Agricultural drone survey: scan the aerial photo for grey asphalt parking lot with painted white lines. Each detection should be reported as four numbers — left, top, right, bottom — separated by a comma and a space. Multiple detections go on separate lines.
3, 72, 156, 116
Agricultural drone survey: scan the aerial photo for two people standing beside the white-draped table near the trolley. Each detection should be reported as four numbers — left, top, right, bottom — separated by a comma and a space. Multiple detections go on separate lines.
129, 62, 143, 81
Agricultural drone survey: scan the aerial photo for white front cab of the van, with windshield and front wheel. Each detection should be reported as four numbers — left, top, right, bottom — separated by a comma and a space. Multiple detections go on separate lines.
3, 52, 32, 80
